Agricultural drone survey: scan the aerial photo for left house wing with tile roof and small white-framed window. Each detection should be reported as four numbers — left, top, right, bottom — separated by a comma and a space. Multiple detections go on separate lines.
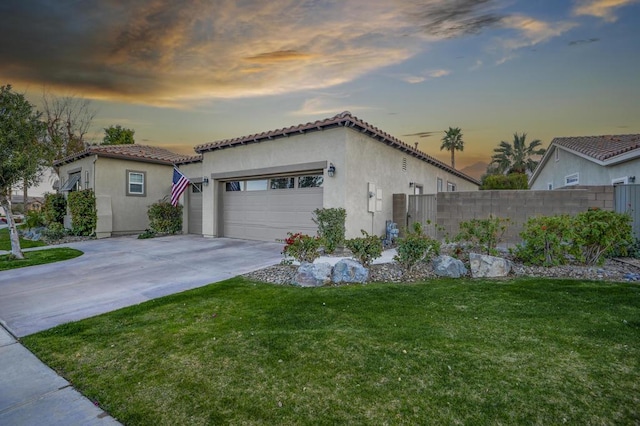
54, 144, 198, 238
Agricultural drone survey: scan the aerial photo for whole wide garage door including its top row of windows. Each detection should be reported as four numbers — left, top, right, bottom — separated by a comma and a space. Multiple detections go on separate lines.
222, 174, 323, 241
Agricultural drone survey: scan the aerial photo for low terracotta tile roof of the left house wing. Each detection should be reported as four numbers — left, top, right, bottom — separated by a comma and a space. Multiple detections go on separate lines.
54, 144, 201, 166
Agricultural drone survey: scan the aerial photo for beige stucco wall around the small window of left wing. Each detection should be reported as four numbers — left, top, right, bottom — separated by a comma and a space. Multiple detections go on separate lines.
59, 155, 173, 237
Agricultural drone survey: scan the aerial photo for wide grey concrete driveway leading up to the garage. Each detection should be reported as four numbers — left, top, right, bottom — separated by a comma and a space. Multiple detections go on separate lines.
0, 235, 282, 337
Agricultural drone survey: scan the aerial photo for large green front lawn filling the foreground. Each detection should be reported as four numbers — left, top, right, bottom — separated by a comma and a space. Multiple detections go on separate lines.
23, 278, 640, 425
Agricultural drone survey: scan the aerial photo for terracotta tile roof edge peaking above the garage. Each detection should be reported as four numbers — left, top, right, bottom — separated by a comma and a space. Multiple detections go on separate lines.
194, 111, 480, 185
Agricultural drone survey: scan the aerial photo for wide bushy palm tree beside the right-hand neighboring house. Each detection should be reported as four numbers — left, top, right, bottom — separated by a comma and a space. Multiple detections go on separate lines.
491, 132, 546, 173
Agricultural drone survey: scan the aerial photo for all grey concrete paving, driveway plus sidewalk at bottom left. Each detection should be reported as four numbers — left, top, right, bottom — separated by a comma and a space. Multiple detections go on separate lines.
0, 235, 282, 426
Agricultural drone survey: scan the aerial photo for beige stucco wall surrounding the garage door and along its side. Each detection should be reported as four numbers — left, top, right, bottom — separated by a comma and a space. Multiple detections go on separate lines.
202, 127, 478, 238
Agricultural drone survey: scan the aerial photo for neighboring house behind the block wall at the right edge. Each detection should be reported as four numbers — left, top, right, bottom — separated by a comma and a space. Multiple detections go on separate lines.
529, 134, 640, 189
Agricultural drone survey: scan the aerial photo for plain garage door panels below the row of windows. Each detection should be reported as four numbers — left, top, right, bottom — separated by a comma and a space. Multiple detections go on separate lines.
222, 188, 322, 241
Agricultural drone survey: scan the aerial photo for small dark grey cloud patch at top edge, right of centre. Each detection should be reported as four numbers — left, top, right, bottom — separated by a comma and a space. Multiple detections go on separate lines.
410, 0, 504, 38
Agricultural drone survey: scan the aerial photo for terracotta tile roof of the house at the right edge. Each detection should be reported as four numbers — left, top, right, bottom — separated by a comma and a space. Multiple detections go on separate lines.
551, 134, 640, 161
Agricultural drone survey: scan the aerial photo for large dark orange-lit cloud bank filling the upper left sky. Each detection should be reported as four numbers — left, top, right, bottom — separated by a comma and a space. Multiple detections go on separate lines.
0, 0, 502, 105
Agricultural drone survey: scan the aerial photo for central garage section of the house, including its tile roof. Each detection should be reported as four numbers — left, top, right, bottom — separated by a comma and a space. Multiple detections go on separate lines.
190, 112, 480, 241
